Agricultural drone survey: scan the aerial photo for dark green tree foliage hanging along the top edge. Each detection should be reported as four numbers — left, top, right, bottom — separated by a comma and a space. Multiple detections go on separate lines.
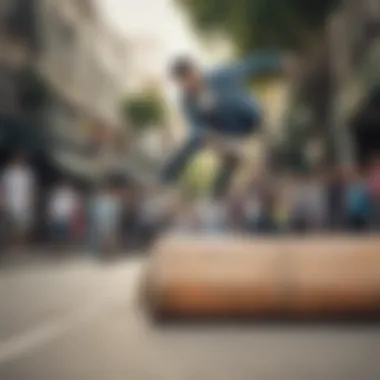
177, 0, 338, 53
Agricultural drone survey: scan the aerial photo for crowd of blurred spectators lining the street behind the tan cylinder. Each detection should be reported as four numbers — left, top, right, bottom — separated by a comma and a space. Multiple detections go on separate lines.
0, 156, 380, 254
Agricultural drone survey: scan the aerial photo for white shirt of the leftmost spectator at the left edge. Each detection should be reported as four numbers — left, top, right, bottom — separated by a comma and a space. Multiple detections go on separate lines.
2, 166, 35, 213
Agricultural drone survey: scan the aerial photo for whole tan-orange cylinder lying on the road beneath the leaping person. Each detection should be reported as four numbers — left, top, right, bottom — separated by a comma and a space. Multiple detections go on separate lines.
145, 237, 380, 317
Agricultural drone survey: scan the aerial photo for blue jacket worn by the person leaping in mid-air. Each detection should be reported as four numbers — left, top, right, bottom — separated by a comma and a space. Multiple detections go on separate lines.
182, 52, 281, 137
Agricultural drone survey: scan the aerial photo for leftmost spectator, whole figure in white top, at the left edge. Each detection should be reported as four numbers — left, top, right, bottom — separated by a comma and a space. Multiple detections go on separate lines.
1, 155, 36, 246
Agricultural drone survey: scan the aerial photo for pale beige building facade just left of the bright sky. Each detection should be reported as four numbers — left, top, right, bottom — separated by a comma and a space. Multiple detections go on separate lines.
39, 0, 127, 177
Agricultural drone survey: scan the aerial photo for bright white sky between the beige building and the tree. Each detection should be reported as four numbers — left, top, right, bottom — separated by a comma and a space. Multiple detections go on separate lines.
97, 0, 233, 137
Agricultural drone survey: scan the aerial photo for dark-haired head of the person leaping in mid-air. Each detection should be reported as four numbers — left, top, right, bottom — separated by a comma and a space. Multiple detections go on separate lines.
170, 57, 203, 93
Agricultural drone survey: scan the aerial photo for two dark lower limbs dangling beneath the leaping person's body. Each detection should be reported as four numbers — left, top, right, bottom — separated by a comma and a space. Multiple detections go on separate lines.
162, 138, 239, 198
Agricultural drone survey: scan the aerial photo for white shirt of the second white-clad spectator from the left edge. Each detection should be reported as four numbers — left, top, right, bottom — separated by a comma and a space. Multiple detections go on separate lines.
49, 187, 78, 220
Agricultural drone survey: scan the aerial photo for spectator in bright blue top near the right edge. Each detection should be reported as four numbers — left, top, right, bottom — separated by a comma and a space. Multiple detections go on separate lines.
345, 169, 370, 232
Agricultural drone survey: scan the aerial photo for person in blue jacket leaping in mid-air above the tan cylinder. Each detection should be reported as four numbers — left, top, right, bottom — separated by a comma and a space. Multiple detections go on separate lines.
162, 52, 295, 198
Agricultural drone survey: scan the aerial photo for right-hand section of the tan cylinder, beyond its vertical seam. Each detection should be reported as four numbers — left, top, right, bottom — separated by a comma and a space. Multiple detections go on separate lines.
286, 238, 380, 316
